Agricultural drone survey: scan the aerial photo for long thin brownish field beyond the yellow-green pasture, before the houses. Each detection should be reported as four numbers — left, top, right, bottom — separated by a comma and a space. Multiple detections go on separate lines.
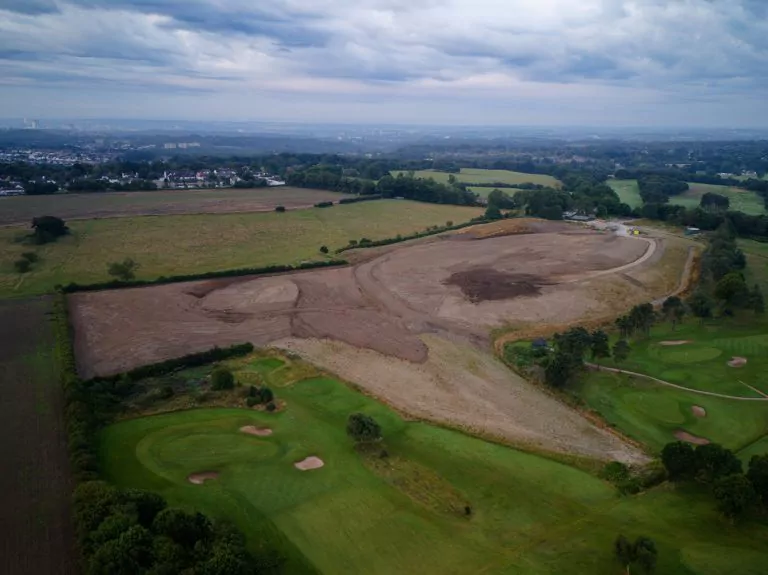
0, 186, 350, 225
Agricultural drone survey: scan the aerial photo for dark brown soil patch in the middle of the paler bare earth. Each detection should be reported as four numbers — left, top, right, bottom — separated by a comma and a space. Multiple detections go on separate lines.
445, 268, 547, 302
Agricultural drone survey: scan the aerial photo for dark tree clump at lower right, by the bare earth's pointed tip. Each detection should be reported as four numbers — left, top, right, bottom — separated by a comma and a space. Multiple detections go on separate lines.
661, 441, 768, 518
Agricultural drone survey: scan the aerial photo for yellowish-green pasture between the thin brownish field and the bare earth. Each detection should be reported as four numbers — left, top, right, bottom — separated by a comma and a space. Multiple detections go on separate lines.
0, 200, 482, 297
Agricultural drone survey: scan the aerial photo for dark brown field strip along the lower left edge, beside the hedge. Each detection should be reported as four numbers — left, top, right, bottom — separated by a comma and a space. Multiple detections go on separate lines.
0, 299, 75, 575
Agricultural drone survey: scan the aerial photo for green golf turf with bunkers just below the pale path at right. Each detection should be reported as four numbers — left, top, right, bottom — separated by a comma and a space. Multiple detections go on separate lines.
576, 371, 768, 453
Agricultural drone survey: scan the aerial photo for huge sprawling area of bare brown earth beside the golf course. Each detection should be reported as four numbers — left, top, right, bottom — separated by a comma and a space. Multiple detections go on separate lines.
70, 224, 664, 461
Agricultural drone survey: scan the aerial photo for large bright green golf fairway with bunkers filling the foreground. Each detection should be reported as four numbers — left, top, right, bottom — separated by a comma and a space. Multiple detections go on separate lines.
101, 357, 768, 575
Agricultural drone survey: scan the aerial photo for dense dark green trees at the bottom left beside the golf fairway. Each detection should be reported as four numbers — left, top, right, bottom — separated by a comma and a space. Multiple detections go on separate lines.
74, 481, 272, 575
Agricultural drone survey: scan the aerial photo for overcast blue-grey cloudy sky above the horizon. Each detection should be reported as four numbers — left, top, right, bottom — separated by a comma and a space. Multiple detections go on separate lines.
0, 0, 768, 127
